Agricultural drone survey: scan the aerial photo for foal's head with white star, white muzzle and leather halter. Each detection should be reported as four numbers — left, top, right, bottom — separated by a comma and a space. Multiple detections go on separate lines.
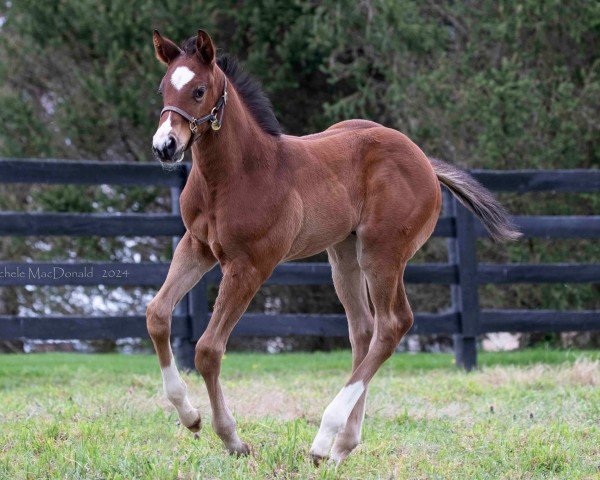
152, 30, 226, 164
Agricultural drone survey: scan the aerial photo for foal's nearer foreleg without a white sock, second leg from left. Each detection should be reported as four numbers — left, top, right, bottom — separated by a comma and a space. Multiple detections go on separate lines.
195, 260, 271, 455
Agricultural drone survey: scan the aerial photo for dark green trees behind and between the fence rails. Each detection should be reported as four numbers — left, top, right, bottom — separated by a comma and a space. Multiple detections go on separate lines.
0, 0, 600, 348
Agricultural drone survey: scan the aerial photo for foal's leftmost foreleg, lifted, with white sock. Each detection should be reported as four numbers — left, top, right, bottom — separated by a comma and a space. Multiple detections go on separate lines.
146, 233, 216, 432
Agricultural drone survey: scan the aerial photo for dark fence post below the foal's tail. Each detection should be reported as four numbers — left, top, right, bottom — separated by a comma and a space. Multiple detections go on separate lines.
446, 195, 479, 371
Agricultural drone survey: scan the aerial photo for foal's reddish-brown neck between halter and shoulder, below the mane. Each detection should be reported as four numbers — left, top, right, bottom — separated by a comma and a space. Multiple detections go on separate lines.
192, 87, 277, 187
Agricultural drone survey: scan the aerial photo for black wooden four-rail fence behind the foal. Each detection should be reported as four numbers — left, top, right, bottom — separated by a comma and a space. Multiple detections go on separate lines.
0, 159, 600, 369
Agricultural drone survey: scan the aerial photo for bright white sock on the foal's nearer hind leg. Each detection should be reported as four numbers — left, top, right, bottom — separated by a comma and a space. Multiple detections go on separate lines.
310, 380, 365, 457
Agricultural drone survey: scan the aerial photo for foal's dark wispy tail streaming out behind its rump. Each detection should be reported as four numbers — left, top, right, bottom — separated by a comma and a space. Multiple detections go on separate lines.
429, 158, 522, 242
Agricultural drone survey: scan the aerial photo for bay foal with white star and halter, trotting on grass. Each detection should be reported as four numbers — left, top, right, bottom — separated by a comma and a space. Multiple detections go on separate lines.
146, 30, 520, 463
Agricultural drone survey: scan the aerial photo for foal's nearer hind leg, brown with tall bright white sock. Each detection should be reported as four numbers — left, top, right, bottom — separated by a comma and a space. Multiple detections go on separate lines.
310, 236, 413, 461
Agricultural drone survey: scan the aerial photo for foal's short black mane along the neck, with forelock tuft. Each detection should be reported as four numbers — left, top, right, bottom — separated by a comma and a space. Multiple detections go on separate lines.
181, 37, 282, 136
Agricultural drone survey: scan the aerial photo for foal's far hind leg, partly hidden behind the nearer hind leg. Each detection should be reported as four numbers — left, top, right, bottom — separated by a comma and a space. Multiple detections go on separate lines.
327, 235, 373, 462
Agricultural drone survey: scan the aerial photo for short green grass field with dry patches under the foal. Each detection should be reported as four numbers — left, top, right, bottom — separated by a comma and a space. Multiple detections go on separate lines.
0, 350, 600, 480
